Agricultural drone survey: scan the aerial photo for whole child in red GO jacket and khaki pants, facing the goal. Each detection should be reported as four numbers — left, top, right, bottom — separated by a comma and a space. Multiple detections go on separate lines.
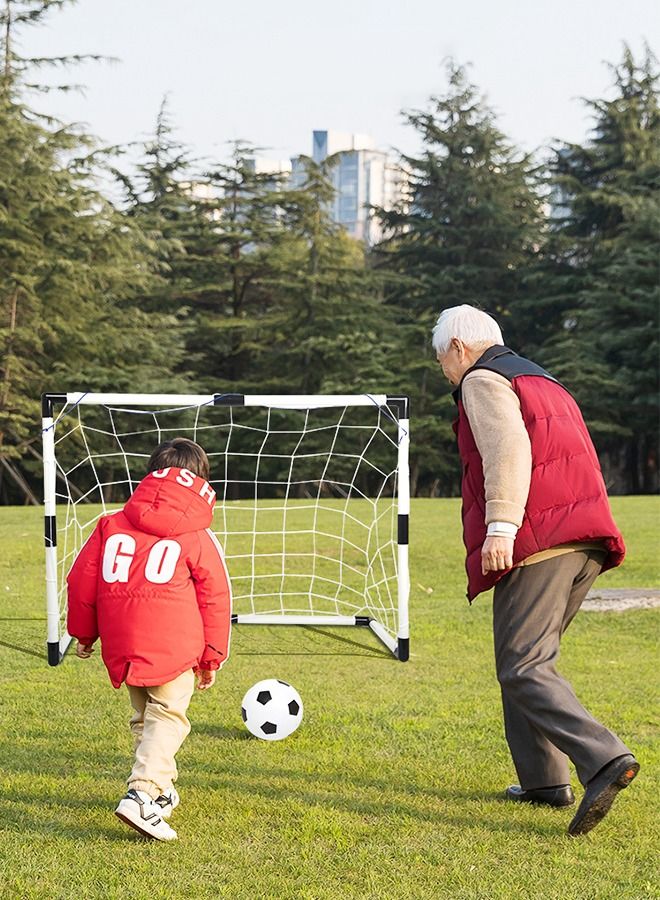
67, 438, 231, 841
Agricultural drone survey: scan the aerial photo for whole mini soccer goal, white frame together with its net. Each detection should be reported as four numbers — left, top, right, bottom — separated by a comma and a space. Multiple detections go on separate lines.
42, 392, 410, 665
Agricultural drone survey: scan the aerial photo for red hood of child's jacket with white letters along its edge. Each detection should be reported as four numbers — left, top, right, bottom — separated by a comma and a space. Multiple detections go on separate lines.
124, 467, 215, 537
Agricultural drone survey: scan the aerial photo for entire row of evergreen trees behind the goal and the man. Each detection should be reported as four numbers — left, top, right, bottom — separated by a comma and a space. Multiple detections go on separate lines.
0, 0, 660, 502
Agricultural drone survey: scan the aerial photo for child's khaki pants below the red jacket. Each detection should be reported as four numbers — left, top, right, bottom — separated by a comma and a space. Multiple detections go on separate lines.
126, 669, 195, 799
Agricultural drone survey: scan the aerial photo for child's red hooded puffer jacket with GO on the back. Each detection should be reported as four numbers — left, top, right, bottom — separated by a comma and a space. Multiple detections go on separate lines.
67, 468, 231, 688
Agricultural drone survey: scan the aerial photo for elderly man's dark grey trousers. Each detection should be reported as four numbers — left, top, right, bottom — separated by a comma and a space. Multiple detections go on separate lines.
493, 550, 630, 790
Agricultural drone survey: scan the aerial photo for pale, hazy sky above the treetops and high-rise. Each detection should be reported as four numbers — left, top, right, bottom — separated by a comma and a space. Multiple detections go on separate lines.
20, 0, 660, 160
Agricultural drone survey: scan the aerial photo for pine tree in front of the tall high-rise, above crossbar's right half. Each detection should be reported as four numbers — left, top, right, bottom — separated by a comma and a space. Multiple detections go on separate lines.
276, 157, 394, 393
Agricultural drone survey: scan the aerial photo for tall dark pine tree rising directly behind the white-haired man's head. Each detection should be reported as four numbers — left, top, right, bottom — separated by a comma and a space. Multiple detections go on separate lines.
376, 62, 541, 494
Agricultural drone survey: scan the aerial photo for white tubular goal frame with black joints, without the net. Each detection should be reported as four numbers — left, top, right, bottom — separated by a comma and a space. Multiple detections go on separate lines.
42, 391, 410, 666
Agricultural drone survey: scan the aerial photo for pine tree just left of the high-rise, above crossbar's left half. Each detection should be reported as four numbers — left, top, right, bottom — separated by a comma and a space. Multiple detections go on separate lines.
180, 142, 310, 393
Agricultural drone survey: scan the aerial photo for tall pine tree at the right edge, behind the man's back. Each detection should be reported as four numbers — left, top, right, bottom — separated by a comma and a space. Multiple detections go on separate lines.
521, 48, 660, 493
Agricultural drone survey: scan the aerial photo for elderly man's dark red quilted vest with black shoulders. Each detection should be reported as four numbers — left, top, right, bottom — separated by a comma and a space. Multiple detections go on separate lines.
454, 346, 625, 601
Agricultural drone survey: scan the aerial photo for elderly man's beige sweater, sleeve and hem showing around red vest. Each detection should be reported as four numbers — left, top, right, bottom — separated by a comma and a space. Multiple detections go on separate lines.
461, 369, 603, 565
